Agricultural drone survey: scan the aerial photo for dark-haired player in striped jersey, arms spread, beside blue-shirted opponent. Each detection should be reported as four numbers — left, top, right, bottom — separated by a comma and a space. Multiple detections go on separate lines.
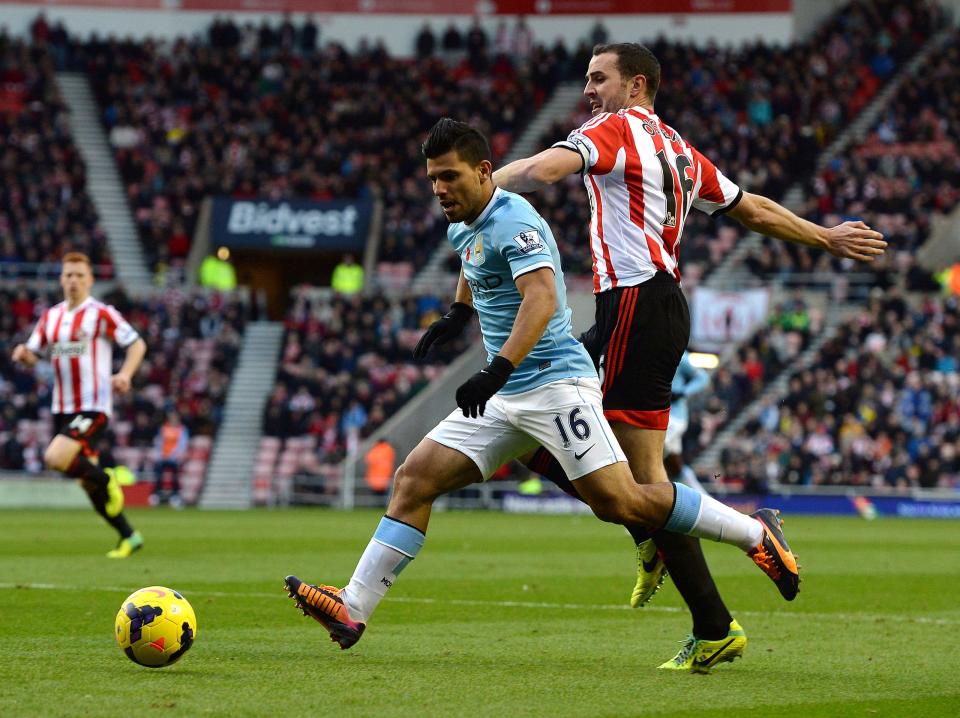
493, 43, 886, 672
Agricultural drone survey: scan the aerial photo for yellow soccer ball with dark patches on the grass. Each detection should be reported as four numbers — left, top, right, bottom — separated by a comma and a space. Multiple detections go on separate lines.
115, 586, 197, 668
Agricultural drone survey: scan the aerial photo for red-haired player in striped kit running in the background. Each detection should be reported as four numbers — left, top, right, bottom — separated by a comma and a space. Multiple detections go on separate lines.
12, 252, 147, 558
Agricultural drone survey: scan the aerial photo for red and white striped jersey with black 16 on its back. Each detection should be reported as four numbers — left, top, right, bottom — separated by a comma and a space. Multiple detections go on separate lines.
554, 106, 743, 292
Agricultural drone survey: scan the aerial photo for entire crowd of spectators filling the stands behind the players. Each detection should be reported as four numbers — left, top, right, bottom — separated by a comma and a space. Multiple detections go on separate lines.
0, 5, 960, 504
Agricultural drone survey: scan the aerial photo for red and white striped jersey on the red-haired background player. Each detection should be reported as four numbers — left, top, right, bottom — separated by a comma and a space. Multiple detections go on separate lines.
27, 297, 140, 416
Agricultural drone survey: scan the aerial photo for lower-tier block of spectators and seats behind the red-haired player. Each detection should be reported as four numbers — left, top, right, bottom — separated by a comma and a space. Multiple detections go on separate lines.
0, 289, 246, 503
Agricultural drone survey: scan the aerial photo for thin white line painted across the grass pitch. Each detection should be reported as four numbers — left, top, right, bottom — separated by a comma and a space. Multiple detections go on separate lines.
0, 583, 960, 626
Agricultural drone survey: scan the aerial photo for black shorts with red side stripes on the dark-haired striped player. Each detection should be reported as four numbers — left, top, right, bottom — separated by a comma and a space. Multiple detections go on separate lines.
582, 272, 690, 431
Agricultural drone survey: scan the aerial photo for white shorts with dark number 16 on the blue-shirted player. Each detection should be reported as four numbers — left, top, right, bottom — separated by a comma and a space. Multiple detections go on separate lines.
427, 377, 627, 481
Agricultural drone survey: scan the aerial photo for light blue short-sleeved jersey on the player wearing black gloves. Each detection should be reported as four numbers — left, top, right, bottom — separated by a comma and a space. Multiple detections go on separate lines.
447, 188, 597, 394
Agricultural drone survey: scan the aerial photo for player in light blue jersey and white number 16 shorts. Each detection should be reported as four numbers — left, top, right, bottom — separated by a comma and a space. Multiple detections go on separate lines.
284, 119, 796, 648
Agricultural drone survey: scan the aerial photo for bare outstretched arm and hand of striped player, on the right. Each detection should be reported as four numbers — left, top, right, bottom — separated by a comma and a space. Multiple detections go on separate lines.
728, 192, 887, 262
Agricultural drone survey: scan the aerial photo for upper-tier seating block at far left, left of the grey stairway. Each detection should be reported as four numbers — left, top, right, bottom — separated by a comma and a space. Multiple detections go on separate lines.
0, 29, 113, 279
